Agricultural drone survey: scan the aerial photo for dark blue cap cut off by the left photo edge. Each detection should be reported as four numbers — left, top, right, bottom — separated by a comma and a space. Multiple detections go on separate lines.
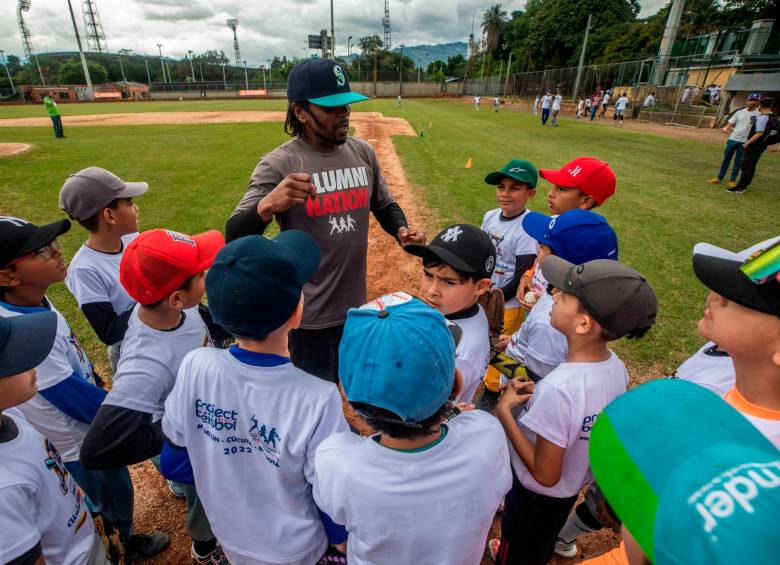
0, 312, 57, 377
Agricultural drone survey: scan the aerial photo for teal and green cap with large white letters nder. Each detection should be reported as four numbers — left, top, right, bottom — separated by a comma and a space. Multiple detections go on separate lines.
589, 379, 780, 565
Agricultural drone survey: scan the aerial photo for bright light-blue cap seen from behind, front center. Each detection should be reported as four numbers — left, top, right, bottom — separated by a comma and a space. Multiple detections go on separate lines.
339, 292, 455, 423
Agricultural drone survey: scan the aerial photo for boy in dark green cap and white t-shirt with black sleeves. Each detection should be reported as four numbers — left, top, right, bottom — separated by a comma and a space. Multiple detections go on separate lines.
478, 159, 539, 410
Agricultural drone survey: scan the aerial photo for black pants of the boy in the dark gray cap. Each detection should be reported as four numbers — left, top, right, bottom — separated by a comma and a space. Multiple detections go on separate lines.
496, 477, 577, 565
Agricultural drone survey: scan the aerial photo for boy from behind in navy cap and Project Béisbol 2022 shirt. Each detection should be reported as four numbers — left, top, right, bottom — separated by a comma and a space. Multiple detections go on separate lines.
161, 230, 348, 565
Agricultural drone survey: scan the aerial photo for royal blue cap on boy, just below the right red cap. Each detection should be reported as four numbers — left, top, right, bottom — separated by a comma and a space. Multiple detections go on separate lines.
523, 209, 618, 265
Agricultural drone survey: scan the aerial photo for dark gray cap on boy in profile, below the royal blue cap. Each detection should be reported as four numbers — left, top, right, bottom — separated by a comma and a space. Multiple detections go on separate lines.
542, 255, 658, 339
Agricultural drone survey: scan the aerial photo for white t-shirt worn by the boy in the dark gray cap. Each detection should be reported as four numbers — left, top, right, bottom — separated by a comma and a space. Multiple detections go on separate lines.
509, 351, 628, 498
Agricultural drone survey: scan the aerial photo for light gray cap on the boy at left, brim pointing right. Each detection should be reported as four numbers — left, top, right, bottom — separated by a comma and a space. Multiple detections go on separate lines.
60, 167, 149, 222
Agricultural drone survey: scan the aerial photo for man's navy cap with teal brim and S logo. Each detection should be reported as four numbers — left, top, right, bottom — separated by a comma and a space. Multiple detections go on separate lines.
287, 59, 368, 107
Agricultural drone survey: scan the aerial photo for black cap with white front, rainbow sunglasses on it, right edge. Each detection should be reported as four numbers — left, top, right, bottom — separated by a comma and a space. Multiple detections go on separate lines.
693, 236, 780, 316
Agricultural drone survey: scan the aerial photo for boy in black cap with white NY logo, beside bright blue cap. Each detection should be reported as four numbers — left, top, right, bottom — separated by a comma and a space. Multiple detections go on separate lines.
404, 224, 496, 404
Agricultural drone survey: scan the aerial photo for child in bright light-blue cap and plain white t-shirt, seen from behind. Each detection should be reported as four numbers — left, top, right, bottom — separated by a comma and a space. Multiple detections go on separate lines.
314, 293, 511, 565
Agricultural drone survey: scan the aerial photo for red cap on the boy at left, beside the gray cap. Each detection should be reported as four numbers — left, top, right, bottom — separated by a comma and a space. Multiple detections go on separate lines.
119, 229, 225, 304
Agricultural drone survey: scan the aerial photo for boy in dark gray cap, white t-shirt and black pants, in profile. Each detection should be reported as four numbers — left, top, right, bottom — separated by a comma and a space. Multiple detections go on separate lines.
490, 257, 658, 565
